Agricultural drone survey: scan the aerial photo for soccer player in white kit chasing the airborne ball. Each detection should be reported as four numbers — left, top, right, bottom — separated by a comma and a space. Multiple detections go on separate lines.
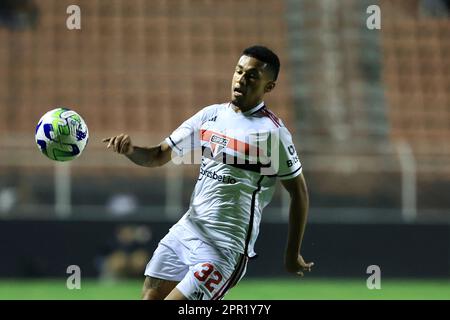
103, 46, 314, 300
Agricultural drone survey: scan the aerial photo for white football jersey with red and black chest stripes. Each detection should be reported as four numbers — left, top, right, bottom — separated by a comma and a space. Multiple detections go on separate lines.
165, 102, 302, 257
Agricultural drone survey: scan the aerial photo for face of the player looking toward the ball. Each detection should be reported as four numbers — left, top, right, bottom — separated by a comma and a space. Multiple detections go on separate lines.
231, 55, 275, 110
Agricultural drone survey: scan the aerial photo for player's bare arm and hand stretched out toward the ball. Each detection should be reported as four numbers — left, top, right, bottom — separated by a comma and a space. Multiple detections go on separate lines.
102, 133, 172, 167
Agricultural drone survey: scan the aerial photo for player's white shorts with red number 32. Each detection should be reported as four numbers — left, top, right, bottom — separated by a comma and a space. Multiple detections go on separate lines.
144, 224, 248, 300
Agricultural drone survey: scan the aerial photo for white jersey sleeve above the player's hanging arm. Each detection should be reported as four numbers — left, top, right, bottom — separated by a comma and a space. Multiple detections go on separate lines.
277, 127, 302, 180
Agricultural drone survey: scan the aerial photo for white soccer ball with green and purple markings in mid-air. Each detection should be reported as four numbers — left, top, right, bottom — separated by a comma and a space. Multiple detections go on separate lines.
35, 108, 89, 161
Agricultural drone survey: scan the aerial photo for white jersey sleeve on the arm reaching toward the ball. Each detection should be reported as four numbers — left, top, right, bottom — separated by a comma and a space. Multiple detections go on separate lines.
165, 108, 205, 156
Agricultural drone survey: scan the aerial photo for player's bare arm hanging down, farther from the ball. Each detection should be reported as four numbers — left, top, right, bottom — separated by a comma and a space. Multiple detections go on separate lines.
281, 174, 314, 276
